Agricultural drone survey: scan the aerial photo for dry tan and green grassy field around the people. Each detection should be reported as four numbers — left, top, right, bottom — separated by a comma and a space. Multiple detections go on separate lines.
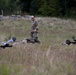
0, 17, 76, 75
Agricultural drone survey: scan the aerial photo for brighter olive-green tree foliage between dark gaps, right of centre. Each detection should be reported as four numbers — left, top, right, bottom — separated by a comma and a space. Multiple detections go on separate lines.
39, 0, 59, 16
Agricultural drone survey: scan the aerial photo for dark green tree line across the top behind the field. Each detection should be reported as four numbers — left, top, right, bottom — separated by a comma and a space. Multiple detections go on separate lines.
0, 0, 76, 17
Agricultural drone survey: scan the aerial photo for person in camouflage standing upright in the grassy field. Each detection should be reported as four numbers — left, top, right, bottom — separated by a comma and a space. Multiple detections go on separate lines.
31, 16, 38, 40
